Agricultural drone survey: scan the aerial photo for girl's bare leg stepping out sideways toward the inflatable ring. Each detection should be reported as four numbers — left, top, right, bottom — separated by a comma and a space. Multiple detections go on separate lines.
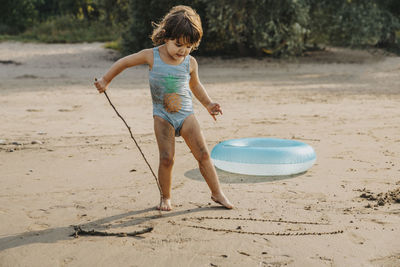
180, 115, 233, 209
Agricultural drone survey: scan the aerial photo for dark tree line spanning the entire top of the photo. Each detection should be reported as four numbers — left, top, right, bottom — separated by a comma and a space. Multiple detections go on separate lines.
0, 0, 400, 56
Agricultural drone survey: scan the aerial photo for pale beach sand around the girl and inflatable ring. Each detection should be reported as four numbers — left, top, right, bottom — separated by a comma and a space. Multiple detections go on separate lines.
0, 42, 400, 266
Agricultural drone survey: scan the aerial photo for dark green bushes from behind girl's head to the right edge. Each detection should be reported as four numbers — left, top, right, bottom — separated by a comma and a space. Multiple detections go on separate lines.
123, 0, 400, 56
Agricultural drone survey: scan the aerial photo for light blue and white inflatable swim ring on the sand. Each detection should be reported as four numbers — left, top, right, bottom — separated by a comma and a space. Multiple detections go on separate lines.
211, 138, 316, 176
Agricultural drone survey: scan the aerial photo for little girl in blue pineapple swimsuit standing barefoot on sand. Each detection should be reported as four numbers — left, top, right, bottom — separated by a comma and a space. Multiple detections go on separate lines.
94, 6, 233, 211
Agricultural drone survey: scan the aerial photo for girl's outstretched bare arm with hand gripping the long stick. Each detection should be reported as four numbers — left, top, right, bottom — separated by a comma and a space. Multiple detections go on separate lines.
94, 49, 153, 93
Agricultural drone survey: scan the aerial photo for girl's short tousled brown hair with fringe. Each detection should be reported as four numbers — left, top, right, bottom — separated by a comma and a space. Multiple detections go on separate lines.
151, 5, 203, 48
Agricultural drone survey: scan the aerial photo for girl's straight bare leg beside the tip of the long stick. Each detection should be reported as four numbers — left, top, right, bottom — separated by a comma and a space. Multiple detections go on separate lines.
154, 116, 175, 211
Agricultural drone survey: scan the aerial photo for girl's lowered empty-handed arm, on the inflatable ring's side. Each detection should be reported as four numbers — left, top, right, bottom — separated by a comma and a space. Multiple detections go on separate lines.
189, 56, 222, 120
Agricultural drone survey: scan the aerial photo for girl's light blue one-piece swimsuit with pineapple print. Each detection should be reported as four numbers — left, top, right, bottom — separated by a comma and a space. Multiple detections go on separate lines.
149, 47, 193, 136
